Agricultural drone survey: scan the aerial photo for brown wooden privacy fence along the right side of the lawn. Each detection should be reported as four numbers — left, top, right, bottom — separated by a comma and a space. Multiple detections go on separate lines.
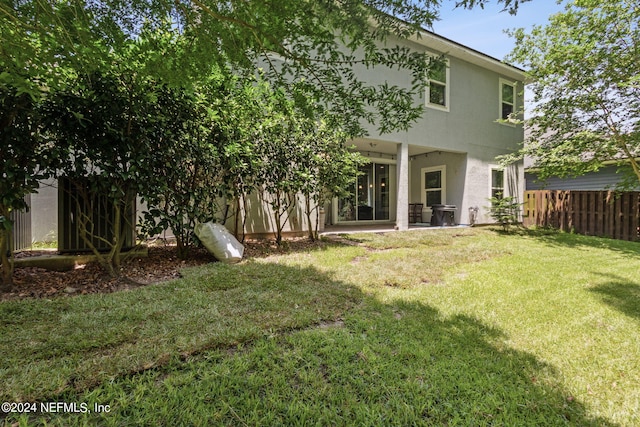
522, 190, 640, 241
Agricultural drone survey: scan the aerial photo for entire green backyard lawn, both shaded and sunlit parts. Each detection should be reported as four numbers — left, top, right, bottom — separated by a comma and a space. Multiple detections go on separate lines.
0, 229, 640, 426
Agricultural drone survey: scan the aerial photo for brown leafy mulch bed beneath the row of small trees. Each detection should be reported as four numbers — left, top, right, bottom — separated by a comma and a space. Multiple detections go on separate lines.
0, 238, 338, 301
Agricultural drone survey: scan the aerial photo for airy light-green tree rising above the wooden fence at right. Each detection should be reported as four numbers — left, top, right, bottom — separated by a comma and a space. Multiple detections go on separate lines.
509, 0, 640, 187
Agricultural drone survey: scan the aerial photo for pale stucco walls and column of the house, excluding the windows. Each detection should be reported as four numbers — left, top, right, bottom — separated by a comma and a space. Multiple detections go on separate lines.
340, 30, 524, 227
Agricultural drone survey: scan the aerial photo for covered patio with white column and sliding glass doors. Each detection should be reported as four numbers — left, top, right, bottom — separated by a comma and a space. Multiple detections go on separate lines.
327, 138, 469, 230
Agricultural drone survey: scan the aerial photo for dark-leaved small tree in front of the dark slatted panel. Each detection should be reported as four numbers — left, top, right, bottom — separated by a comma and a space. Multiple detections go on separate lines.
43, 67, 166, 276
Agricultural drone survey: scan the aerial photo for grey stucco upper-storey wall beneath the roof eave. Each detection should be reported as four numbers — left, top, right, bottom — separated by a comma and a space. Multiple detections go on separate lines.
356, 32, 523, 154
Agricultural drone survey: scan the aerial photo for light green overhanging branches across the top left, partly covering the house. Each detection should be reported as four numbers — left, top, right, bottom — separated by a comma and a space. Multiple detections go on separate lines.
0, 0, 518, 139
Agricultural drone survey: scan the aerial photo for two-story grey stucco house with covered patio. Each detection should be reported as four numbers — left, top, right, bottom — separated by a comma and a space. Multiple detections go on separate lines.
320, 31, 524, 229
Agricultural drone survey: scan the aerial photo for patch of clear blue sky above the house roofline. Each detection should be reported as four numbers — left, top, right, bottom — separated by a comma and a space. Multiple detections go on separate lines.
433, 0, 565, 59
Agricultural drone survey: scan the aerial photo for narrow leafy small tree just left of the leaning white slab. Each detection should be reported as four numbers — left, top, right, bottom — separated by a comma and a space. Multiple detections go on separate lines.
139, 82, 227, 259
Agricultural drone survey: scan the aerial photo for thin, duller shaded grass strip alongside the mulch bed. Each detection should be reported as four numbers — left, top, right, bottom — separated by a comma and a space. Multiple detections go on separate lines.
0, 262, 362, 406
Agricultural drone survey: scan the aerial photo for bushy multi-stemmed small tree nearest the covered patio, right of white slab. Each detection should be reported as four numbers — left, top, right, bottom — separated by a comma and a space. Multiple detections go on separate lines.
209, 79, 368, 243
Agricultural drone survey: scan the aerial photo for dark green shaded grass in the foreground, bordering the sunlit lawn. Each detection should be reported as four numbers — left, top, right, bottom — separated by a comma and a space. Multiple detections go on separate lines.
33, 298, 614, 426
